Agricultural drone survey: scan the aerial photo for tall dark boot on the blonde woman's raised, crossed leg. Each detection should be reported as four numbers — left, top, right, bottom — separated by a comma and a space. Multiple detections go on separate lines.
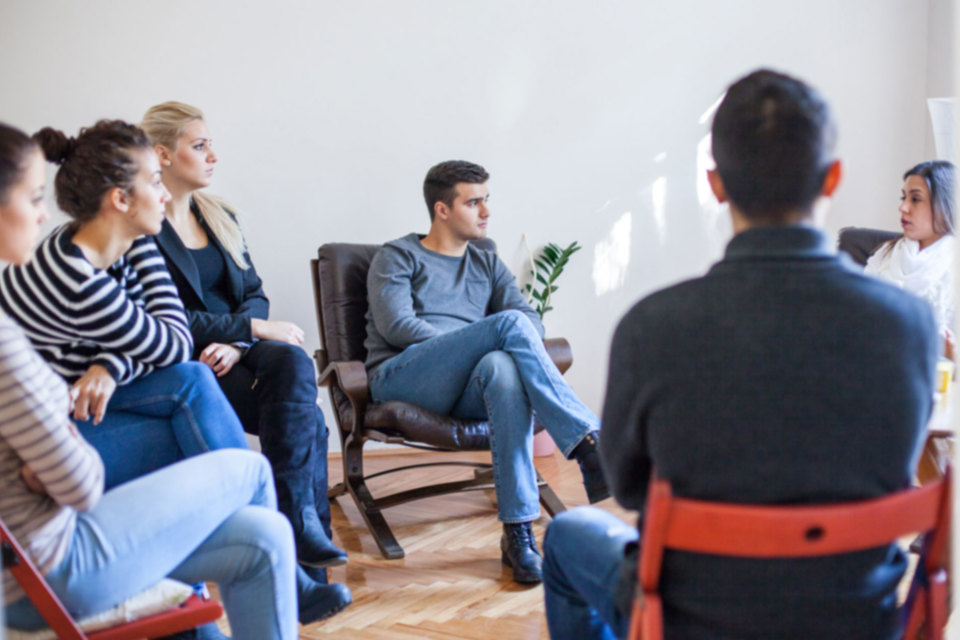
259, 402, 347, 567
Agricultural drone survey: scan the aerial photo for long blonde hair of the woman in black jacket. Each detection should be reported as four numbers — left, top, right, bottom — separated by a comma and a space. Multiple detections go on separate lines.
140, 100, 250, 269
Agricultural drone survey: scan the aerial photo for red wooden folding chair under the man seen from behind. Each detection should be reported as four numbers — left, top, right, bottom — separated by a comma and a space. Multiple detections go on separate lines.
628, 468, 952, 640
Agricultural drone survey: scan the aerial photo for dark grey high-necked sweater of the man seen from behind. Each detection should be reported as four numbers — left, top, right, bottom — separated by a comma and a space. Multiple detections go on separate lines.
600, 227, 939, 640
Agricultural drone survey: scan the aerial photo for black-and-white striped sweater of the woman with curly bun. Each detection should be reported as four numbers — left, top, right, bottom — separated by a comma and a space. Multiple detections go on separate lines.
0, 225, 193, 384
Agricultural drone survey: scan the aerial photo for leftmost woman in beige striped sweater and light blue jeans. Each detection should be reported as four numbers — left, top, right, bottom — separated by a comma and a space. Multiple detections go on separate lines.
0, 124, 344, 640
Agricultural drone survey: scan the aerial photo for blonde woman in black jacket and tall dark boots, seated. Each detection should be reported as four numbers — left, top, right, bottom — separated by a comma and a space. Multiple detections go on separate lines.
141, 102, 347, 566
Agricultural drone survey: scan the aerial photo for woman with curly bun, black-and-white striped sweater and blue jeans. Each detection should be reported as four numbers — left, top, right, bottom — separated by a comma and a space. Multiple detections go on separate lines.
0, 120, 350, 623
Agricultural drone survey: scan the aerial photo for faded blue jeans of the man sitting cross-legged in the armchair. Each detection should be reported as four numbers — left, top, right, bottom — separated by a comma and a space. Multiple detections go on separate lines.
370, 310, 599, 522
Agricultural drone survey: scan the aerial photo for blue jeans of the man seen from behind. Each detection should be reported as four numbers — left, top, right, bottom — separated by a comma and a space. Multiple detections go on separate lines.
543, 507, 638, 640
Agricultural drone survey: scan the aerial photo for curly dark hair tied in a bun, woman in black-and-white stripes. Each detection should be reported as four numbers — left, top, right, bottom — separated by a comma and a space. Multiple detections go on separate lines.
33, 120, 153, 224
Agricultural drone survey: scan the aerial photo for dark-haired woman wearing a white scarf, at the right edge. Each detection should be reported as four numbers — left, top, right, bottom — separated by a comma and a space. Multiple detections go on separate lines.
864, 160, 956, 358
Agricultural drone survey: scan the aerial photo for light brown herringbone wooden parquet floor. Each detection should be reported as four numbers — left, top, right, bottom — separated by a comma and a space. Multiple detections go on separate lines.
212, 452, 628, 640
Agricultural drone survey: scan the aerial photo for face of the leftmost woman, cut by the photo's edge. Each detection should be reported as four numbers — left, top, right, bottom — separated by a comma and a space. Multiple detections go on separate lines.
0, 150, 47, 264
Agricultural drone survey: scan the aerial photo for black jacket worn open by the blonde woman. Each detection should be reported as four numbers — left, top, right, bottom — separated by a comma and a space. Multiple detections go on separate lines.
156, 203, 270, 353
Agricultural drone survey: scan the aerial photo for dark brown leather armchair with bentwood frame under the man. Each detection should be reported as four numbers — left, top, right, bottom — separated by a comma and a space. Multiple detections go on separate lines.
310, 240, 573, 559
